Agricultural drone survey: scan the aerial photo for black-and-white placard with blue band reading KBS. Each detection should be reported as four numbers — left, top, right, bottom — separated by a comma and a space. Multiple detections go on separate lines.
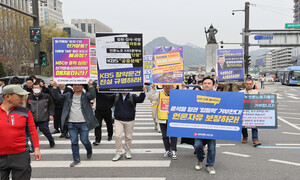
96, 33, 144, 92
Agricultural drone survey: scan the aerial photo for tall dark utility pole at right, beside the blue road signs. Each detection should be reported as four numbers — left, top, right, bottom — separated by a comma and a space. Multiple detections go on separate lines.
244, 2, 250, 74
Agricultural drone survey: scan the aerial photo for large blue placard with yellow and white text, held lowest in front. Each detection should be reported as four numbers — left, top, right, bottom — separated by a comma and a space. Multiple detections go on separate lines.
167, 89, 244, 141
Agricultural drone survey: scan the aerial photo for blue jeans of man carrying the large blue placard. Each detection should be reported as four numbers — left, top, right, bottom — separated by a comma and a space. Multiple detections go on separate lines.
194, 139, 216, 166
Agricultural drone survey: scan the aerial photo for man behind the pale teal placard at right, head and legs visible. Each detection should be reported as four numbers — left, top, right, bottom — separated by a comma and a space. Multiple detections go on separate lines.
240, 78, 261, 147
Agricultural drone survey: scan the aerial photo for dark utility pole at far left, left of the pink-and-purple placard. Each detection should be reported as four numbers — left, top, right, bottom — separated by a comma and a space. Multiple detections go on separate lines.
32, 0, 41, 75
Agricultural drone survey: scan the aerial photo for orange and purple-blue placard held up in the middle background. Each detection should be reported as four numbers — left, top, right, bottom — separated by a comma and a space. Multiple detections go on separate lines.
153, 46, 184, 85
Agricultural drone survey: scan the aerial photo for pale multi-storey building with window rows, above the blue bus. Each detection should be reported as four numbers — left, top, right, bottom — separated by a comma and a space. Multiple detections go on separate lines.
272, 48, 294, 70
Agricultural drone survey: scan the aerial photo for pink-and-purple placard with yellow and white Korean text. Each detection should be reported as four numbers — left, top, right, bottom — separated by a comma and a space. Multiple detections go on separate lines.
52, 38, 90, 84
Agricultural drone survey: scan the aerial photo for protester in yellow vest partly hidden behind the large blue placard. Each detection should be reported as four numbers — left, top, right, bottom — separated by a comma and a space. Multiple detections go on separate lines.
148, 83, 178, 160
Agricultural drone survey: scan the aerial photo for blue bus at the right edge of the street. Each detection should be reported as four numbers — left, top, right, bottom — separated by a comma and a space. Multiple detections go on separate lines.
279, 66, 300, 85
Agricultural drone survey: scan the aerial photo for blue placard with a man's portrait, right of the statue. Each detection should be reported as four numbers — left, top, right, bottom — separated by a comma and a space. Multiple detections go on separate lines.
216, 49, 245, 82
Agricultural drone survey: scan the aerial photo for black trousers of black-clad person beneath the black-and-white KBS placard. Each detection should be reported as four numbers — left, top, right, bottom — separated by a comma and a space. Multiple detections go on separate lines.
95, 110, 113, 141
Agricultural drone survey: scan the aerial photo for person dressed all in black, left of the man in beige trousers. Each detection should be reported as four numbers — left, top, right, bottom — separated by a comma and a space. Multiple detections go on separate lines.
93, 87, 113, 146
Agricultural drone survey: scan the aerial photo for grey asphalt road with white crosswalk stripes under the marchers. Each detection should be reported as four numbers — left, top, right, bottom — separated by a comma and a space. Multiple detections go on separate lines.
32, 83, 300, 180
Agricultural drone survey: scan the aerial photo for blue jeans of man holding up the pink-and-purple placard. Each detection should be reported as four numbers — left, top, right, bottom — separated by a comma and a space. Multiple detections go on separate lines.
68, 122, 92, 161
